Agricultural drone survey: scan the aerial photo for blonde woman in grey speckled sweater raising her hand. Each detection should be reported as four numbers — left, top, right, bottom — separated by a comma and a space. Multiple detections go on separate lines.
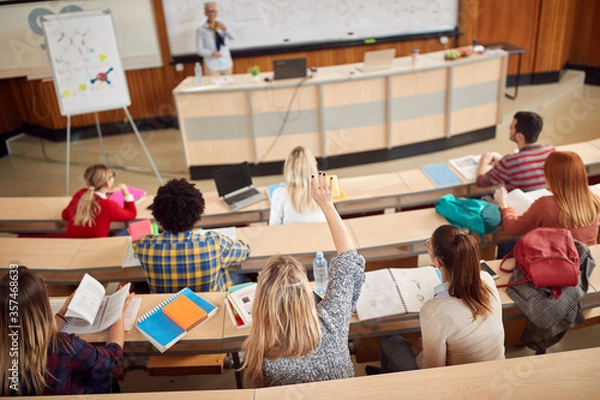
242, 173, 365, 387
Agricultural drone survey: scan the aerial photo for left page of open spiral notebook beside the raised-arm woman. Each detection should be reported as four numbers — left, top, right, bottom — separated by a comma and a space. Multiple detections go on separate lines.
356, 269, 406, 321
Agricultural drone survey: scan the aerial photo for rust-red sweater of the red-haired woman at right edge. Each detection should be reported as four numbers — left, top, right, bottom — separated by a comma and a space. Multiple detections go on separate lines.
502, 196, 600, 246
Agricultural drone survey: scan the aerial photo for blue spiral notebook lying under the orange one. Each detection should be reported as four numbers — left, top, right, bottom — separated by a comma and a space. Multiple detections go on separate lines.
135, 288, 217, 353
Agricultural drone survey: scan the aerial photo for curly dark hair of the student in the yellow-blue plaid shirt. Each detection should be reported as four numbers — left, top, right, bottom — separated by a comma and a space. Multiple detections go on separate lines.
148, 179, 204, 233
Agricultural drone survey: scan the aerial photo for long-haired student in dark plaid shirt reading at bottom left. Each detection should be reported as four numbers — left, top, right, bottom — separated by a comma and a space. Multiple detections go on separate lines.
0, 266, 133, 396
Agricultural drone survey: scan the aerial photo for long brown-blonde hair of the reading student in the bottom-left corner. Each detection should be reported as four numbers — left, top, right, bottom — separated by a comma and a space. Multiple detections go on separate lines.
0, 266, 61, 396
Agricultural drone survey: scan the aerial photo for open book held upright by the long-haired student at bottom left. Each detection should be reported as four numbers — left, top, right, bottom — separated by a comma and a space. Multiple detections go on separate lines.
51, 274, 141, 334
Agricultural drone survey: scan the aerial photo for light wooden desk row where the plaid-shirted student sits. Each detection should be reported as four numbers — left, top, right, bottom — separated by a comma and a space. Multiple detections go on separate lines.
0, 208, 520, 284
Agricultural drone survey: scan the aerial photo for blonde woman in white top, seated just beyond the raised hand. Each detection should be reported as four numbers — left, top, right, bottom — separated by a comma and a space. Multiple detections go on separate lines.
269, 146, 325, 225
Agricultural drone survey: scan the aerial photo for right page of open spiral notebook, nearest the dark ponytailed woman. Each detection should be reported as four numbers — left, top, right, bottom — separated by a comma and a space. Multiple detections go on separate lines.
391, 267, 442, 312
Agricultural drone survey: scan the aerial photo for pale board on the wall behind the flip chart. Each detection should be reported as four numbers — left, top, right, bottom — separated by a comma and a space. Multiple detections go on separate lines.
0, 0, 162, 79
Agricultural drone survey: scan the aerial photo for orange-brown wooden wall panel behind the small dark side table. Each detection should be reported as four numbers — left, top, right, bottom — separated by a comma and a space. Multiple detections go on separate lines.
478, 0, 541, 75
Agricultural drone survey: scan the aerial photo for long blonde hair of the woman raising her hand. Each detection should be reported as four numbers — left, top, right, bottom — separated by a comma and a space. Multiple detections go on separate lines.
242, 256, 321, 387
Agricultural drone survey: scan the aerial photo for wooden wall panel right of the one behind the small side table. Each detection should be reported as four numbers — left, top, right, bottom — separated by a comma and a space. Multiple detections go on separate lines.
533, 0, 576, 73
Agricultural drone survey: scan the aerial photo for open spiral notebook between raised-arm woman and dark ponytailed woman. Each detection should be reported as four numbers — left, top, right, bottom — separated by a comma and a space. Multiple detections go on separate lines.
356, 267, 442, 321
